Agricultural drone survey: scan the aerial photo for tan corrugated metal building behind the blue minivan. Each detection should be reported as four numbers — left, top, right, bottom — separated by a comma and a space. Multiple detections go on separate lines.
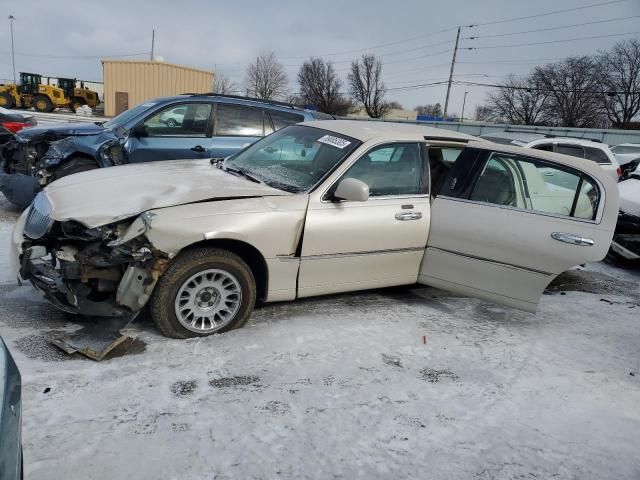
102, 60, 214, 117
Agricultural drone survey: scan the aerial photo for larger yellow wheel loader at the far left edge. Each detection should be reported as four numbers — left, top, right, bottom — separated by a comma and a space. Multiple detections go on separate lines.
0, 72, 69, 112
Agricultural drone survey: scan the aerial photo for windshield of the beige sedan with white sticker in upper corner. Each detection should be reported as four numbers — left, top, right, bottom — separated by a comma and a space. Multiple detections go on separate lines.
225, 125, 361, 193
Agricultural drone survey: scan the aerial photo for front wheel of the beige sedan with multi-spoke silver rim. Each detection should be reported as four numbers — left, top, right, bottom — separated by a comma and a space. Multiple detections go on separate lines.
151, 248, 256, 338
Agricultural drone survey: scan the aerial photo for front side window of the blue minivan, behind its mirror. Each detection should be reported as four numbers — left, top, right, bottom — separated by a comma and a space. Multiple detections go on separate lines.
144, 103, 211, 137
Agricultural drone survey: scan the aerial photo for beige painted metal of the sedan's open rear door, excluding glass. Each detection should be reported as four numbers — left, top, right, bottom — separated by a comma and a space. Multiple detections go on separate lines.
419, 140, 619, 311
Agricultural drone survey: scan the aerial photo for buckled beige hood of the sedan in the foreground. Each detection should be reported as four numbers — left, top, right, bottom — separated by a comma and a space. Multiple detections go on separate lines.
44, 160, 292, 228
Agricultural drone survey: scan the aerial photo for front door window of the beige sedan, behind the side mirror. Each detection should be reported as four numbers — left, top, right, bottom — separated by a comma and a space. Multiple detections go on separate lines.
344, 143, 427, 197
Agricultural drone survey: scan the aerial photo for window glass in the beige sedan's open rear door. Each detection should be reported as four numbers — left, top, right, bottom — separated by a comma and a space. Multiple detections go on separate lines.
469, 153, 600, 219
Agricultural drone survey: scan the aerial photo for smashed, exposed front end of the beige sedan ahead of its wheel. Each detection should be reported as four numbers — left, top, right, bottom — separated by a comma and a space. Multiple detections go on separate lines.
20, 211, 169, 316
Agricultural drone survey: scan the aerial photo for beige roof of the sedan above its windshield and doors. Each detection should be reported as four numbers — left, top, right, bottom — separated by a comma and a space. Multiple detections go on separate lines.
303, 120, 477, 142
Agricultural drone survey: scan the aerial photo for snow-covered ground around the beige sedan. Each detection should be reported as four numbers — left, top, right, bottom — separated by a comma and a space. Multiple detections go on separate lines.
0, 201, 640, 480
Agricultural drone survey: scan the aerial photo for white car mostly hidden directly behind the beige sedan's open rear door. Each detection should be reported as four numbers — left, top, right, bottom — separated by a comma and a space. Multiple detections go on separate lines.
524, 137, 622, 182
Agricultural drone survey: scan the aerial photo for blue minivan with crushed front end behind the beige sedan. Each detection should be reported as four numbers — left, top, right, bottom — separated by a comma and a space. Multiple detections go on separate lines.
0, 94, 333, 207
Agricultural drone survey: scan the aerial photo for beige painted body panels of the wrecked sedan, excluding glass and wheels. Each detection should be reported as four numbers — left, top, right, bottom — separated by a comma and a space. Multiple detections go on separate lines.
13, 121, 618, 311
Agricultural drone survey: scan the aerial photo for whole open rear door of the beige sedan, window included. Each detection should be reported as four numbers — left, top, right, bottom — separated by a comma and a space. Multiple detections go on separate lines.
419, 148, 617, 312
